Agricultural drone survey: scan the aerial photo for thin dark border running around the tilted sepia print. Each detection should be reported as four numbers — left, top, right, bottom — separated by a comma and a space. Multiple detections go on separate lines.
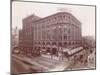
10, 0, 97, 75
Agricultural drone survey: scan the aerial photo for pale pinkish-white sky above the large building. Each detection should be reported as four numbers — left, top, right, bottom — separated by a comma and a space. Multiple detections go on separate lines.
12, 1, 95, 37
